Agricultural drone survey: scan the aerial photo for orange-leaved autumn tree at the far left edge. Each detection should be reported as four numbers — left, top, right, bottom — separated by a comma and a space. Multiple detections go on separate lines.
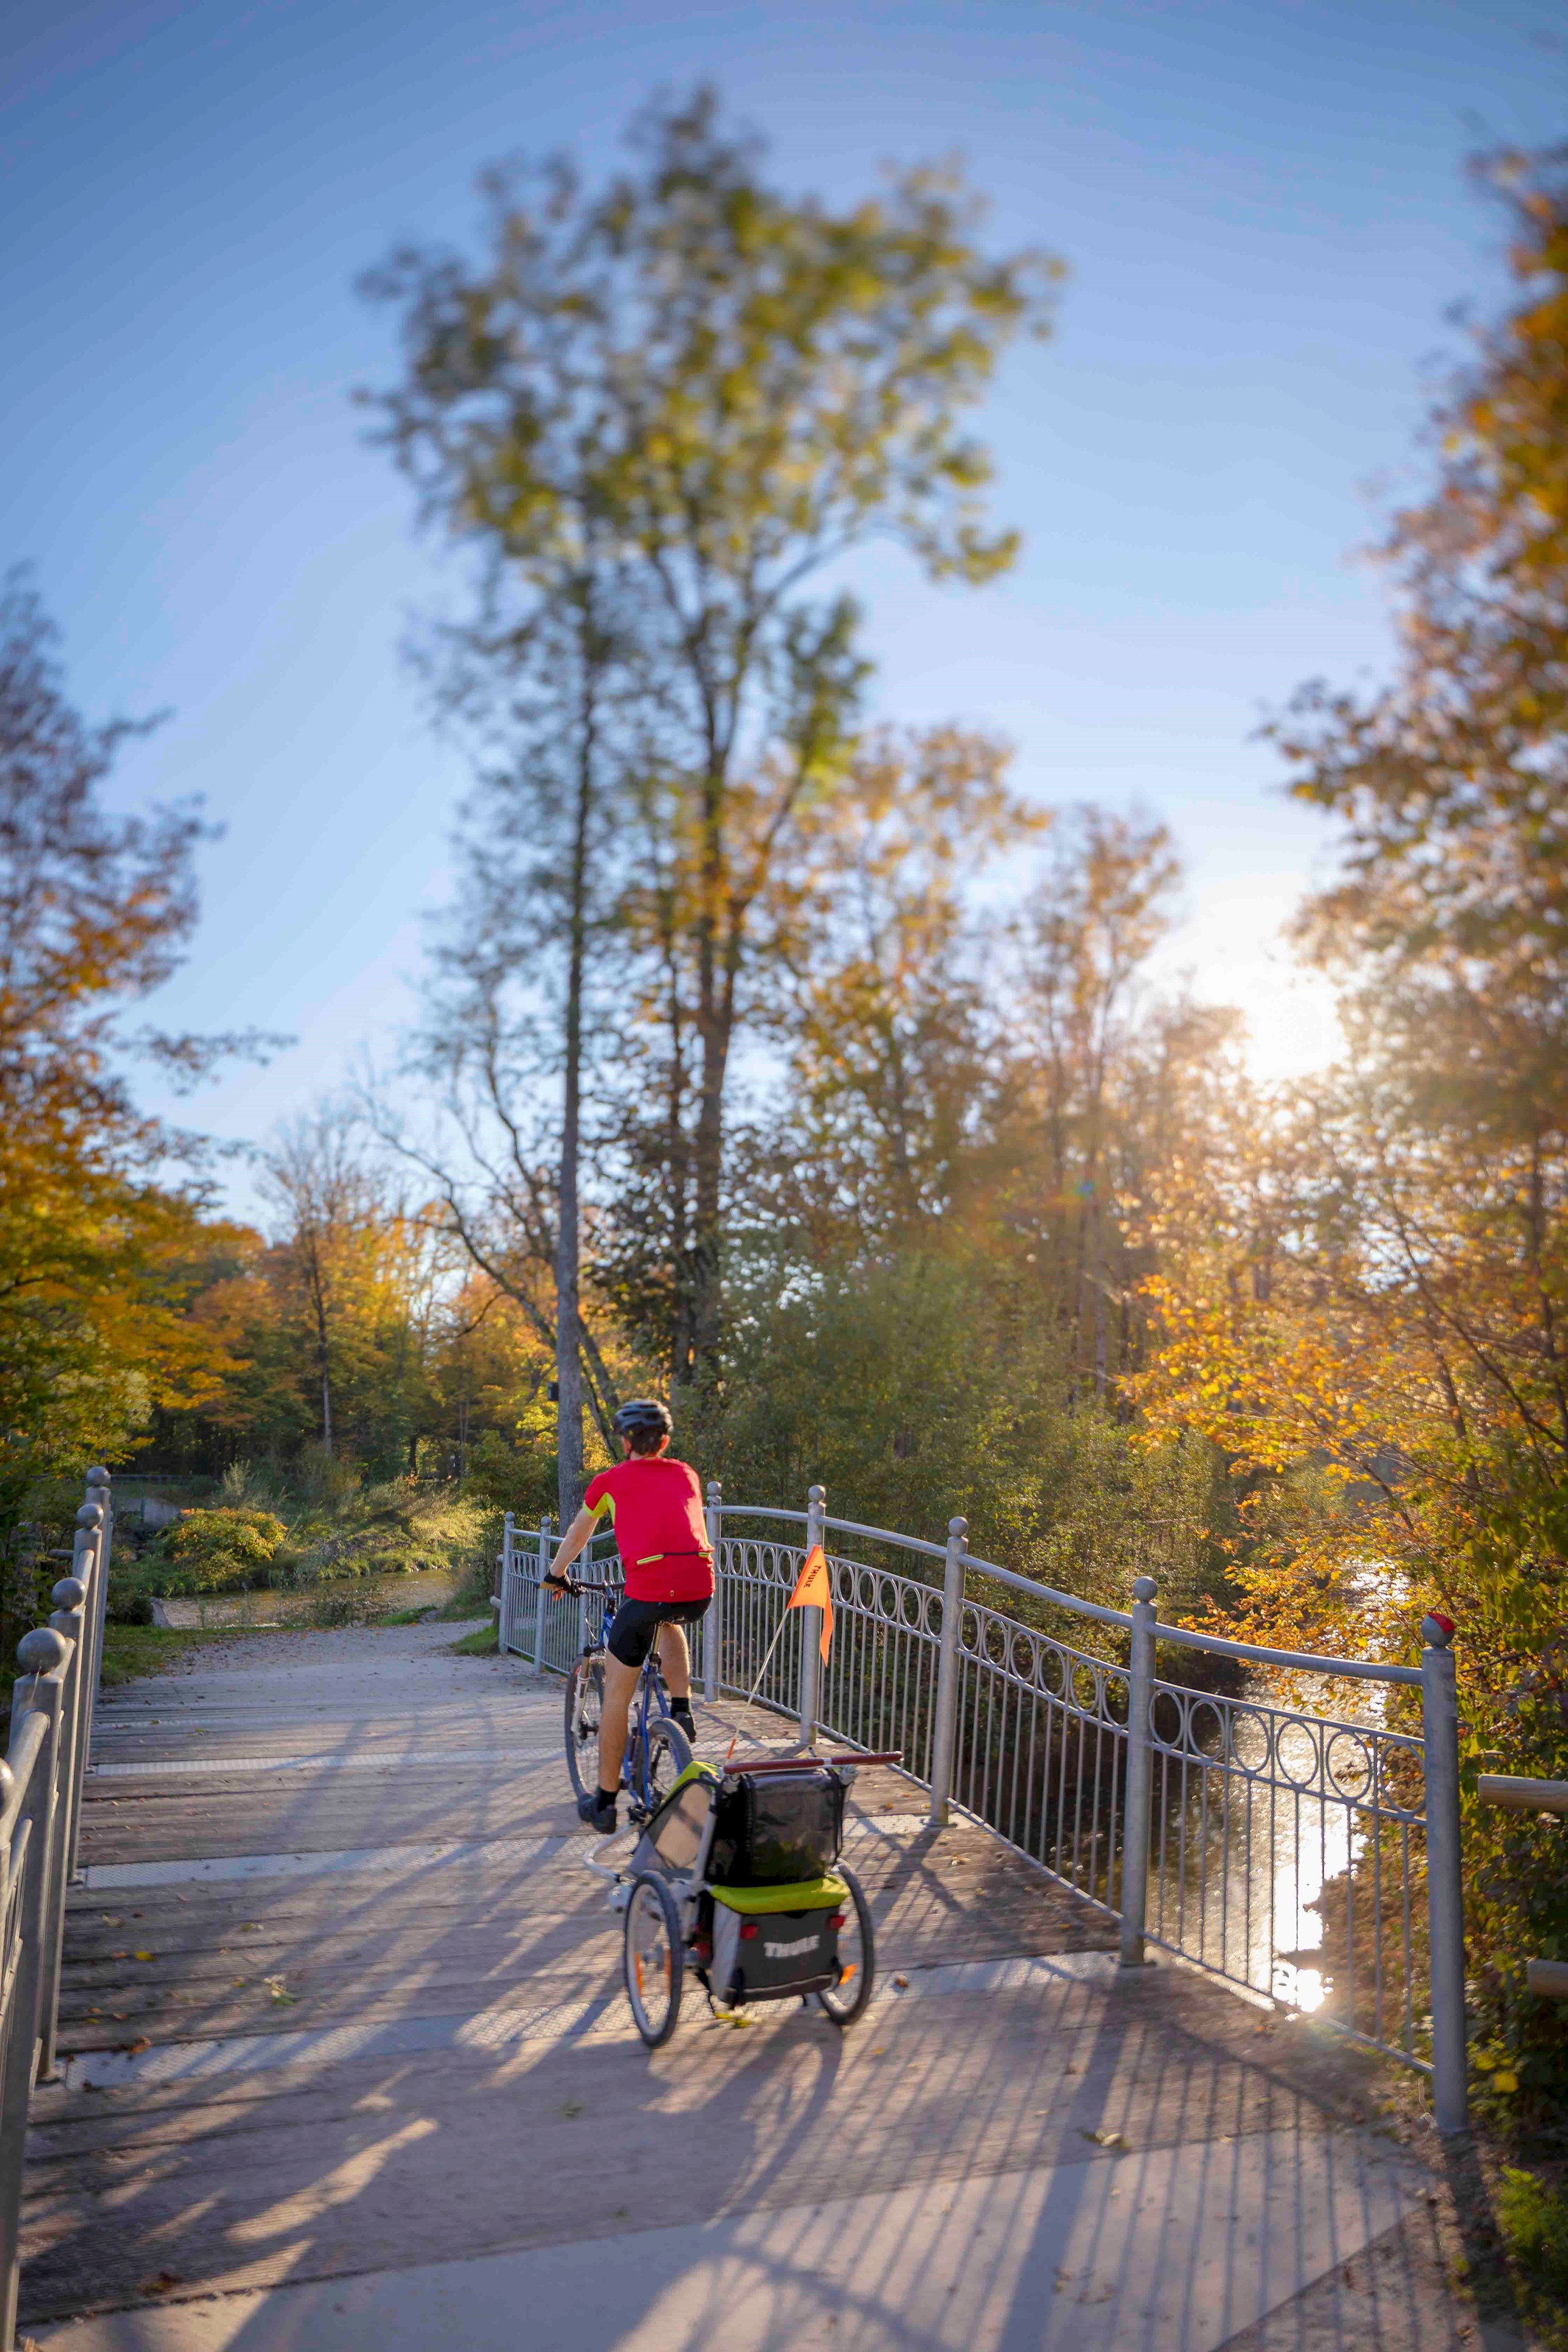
0, 571, 254, 1517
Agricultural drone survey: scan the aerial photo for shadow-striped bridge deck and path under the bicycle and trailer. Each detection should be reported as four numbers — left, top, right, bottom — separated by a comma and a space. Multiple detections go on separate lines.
24, 1625, 1502, 2352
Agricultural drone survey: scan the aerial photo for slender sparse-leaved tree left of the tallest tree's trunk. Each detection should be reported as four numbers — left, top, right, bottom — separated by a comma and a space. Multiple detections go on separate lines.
374, 574, 628, 1524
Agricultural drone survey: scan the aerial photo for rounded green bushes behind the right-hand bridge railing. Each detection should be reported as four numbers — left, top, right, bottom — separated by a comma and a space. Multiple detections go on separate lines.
691, 1258, 1234, 1611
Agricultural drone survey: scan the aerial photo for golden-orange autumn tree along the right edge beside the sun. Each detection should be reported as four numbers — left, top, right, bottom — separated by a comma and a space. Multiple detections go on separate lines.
1145, 150, 1568, 2103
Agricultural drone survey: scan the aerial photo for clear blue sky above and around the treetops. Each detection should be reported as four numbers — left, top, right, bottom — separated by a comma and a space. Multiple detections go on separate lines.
0, 0, 1568, 1204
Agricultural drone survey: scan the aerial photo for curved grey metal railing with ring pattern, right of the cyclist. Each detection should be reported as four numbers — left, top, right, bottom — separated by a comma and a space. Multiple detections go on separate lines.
501, 1481, 1465, 2131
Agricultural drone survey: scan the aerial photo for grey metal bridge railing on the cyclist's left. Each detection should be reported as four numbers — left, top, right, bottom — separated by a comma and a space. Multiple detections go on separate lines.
0, 1470, 115, 2352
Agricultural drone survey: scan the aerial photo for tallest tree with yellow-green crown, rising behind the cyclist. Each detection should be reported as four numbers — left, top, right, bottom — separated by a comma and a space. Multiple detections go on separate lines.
369, 92, 1053, 1380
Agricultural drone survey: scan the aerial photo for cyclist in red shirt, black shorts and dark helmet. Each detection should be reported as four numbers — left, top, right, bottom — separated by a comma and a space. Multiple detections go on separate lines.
545, 1397, 713, 1837
